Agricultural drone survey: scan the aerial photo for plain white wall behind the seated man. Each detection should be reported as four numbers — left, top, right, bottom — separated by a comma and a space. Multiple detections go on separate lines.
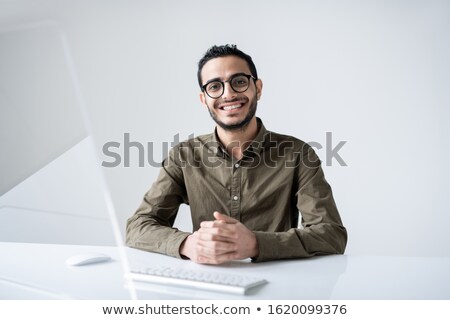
0, 0, 450, 256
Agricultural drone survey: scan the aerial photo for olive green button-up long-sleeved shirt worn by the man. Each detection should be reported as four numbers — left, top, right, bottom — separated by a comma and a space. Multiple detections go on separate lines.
126, 119, 347, 262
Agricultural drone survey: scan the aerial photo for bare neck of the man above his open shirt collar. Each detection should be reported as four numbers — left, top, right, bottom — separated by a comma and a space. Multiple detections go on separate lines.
217, 117, 258, 160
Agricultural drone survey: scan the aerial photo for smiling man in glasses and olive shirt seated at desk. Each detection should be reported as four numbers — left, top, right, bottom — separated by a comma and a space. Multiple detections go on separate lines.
127, 45, 347, 264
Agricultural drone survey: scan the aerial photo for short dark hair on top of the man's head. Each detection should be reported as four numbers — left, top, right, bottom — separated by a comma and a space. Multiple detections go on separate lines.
197, 44, 258, 88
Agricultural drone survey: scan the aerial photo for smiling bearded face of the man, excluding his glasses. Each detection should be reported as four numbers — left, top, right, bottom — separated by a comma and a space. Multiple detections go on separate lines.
200, 56, 262, 131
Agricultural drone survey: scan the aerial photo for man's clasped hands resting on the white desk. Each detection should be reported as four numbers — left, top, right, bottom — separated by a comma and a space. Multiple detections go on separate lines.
180, 211, 259, 264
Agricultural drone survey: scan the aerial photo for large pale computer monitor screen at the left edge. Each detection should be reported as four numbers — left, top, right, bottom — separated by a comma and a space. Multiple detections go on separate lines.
0, 21, 115, 245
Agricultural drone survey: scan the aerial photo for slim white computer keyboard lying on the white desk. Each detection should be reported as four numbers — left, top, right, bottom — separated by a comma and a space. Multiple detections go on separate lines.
125, 267, 267, 294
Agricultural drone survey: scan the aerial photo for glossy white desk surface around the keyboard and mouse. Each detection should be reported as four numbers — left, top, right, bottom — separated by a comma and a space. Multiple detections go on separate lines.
0, 242, 450, 300
